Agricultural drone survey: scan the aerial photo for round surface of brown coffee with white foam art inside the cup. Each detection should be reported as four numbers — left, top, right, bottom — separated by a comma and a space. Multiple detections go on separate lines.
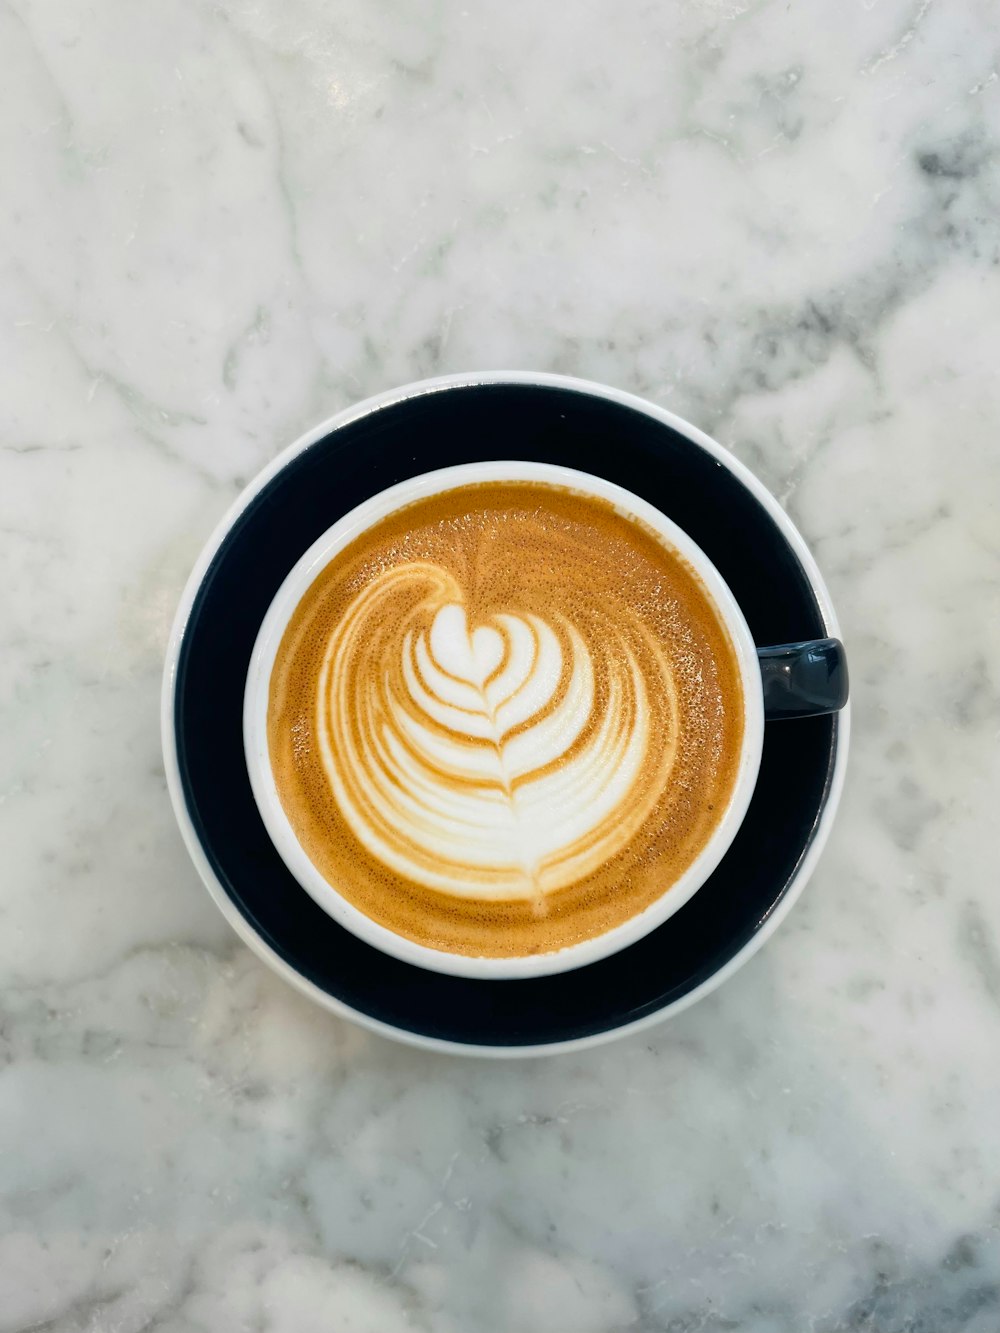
268, 483, 743, 957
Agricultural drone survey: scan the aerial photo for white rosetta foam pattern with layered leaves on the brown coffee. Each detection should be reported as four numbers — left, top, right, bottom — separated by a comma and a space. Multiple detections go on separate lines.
315, 561, 677, 900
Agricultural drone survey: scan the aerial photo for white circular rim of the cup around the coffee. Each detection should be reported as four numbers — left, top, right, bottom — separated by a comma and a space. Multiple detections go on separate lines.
243, 460, 764, 980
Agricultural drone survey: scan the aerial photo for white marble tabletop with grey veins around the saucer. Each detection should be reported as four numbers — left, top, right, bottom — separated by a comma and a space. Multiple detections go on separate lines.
0, 0, 1000, 1333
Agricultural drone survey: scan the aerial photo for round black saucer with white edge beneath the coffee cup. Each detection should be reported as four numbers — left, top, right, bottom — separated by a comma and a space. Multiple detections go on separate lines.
163, 373, 849, 1056
